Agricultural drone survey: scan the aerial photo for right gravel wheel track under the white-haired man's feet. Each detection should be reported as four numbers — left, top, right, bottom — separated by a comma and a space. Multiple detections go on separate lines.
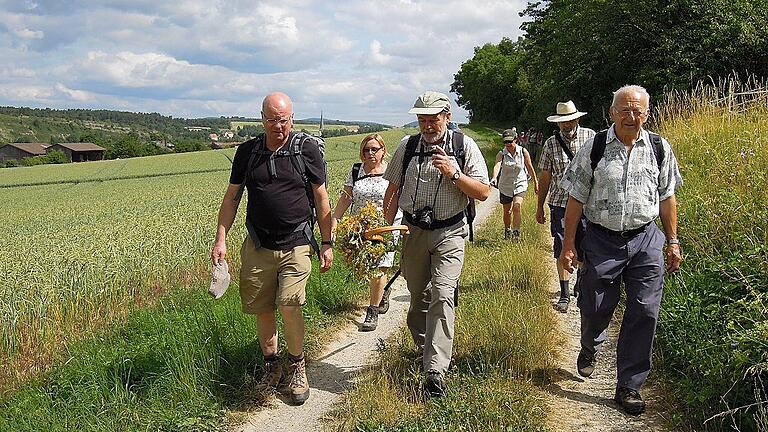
545, 259, 667, 432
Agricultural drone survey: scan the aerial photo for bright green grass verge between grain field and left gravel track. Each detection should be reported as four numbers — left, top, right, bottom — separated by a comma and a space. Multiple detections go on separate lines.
0, 265, 365, 431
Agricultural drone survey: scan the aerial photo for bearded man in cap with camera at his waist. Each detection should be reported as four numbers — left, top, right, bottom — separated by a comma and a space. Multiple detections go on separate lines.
384, 91, 490, 397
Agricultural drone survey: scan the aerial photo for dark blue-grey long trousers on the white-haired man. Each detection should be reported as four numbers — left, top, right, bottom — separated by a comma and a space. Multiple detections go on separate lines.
578, 223, 665, 390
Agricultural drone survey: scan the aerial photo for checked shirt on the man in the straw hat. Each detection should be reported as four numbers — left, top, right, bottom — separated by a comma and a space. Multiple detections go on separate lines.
539, 126, 595, 207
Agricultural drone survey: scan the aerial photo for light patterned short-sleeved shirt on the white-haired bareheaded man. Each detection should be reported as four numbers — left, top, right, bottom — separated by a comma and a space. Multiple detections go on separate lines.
560, 125, 683, 231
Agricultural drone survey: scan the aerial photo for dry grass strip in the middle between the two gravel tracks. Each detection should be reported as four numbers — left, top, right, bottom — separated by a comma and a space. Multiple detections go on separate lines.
334, 126, 557, 431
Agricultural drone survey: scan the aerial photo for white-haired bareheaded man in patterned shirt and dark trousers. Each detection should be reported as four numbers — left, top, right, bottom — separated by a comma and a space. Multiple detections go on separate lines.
560, 85, 683, 414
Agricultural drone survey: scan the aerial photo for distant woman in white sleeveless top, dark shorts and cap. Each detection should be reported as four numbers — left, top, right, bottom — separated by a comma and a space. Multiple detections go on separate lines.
491, 129, 539, 240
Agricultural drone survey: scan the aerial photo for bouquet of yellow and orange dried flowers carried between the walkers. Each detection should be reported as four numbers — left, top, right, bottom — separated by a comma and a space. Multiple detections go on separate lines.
336, 202, 396, 280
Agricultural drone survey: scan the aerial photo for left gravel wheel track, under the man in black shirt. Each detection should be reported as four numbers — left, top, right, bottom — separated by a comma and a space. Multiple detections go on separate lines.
233, 189, 499, 432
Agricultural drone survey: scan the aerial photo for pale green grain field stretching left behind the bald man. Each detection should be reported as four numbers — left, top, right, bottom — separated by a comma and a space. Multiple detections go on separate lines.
0, 130, 403, 395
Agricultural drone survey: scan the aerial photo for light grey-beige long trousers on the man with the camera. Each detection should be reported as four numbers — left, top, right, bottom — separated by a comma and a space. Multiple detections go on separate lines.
400, 221, 469, 373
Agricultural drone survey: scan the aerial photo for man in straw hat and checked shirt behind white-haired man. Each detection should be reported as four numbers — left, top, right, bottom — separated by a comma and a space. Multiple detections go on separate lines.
536, 101, 595, 313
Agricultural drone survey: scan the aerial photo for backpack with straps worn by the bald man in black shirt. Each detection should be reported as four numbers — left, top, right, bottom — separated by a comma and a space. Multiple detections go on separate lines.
236, 132, 327, 256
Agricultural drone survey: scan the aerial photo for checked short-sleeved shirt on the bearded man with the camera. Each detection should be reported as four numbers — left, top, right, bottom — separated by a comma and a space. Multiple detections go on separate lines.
384, 133, 488, 220
